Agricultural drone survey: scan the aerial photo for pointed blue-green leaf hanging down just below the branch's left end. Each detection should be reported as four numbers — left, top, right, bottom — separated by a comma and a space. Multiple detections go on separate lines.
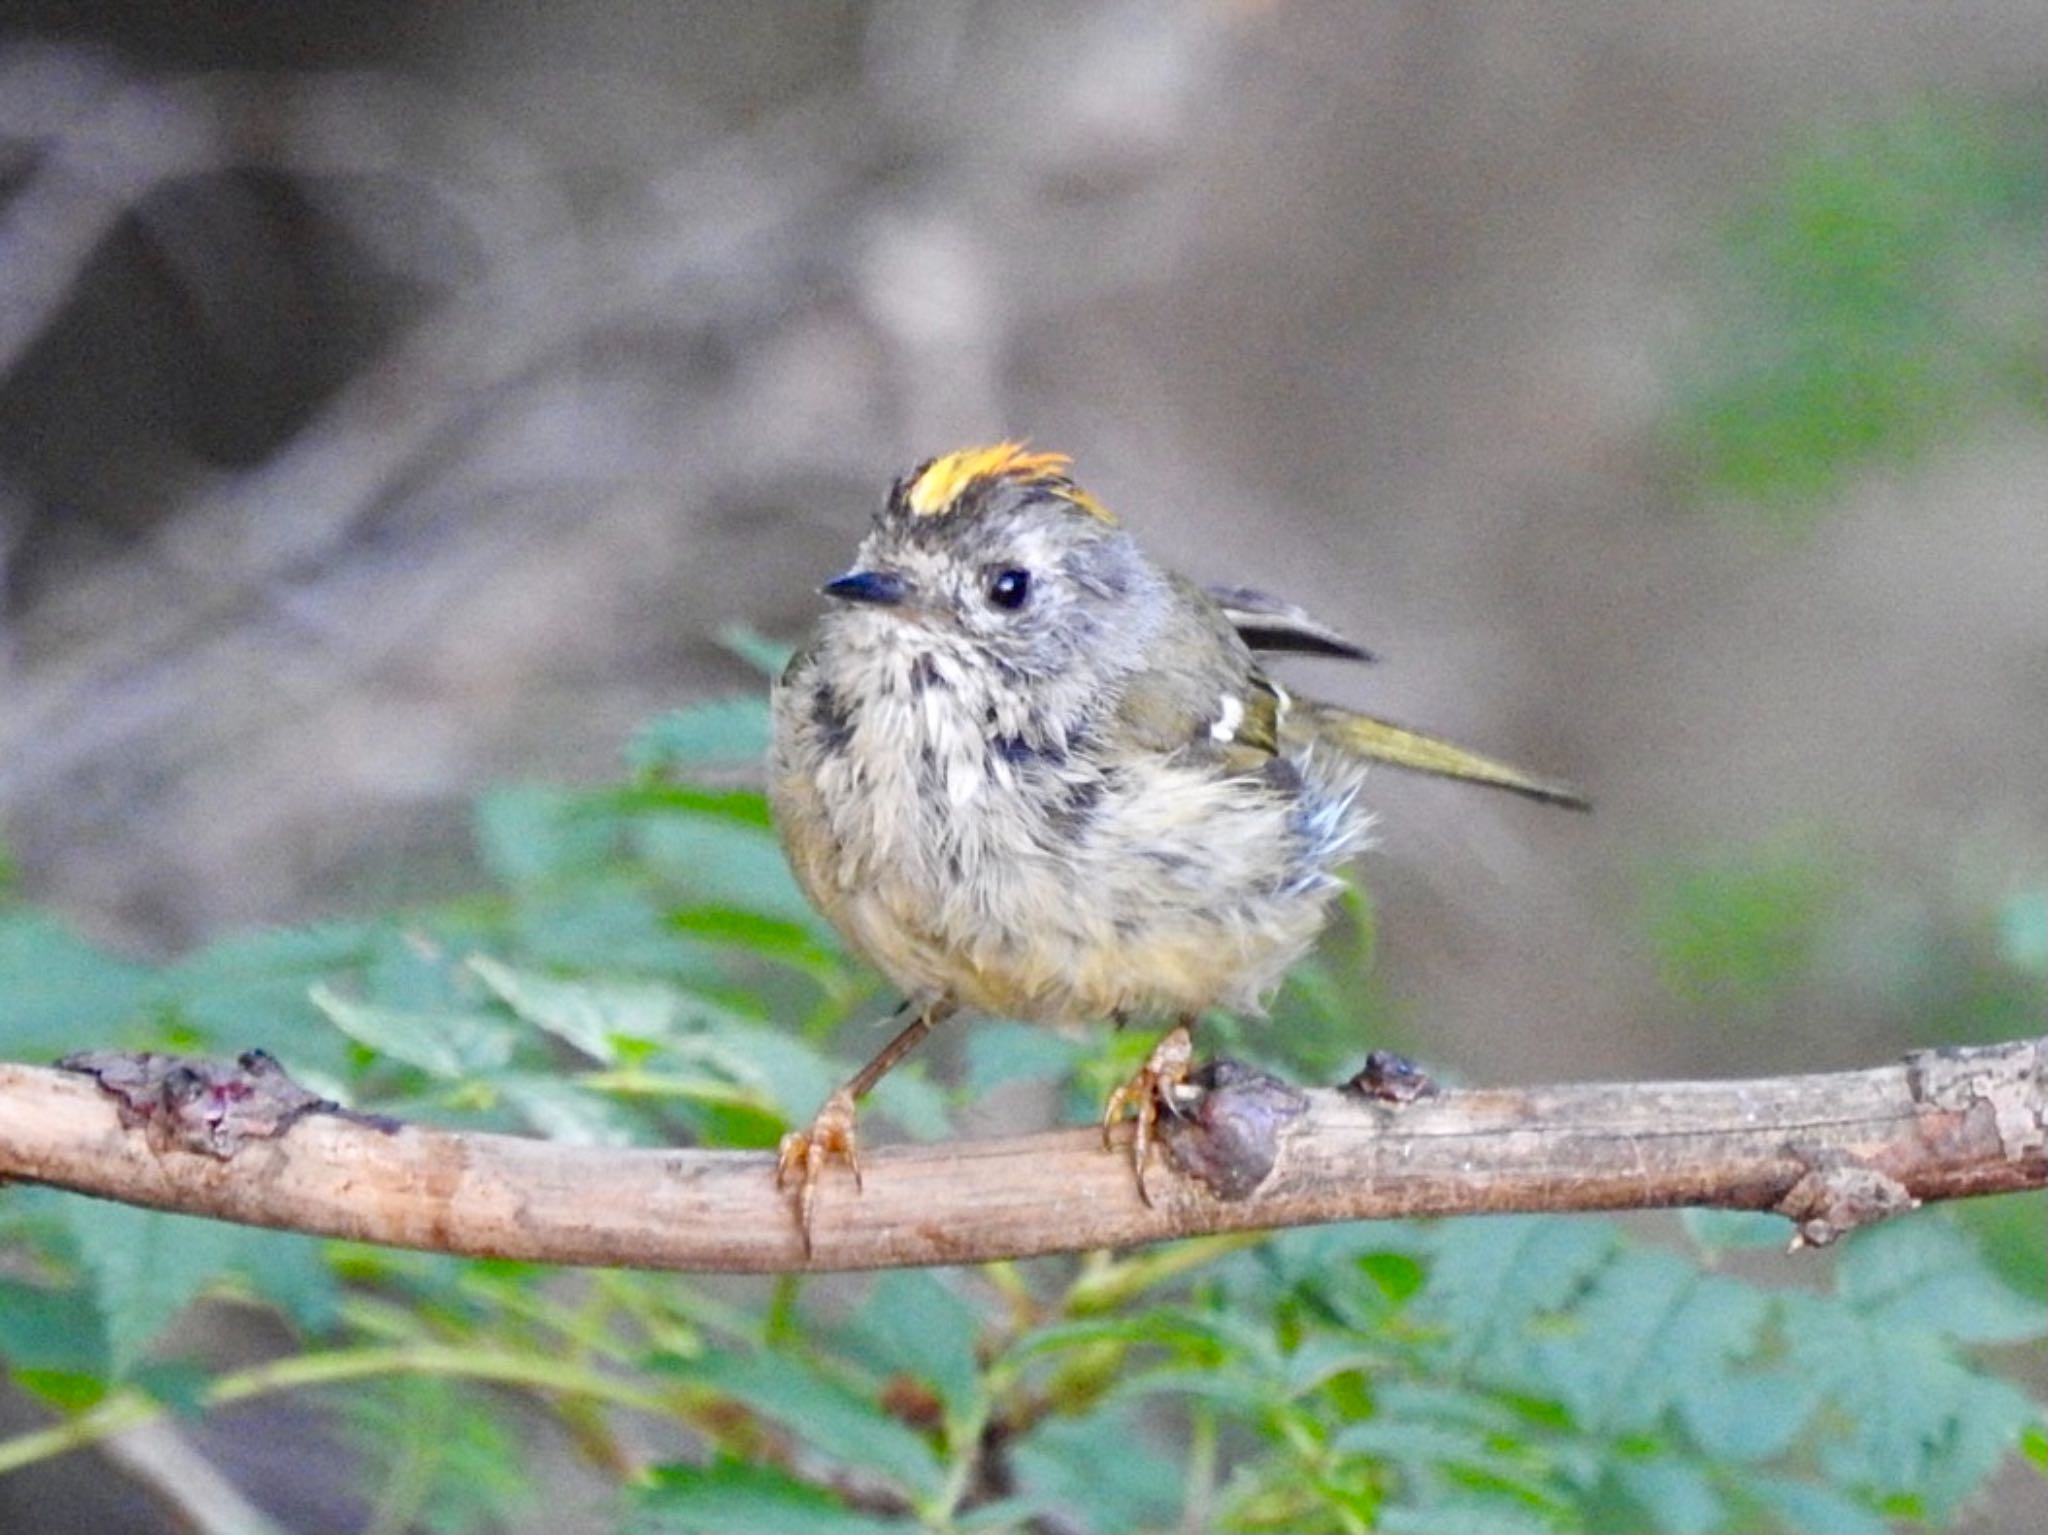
57, 1197, 248, 1377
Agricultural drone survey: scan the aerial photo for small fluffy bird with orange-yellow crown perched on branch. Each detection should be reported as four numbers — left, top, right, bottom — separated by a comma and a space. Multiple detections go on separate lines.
768, 440, 1587, 1251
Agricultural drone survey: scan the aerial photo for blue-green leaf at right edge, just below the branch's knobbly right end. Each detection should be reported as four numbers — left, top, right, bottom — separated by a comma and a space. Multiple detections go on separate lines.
1835, 1212, 2048, 1343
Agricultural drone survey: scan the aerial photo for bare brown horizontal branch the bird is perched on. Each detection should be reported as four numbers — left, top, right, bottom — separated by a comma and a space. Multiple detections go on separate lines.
0, 1040, 2048, 1273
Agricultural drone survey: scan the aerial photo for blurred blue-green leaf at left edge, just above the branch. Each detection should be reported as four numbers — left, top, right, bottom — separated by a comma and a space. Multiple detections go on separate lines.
0, 911, 154, 1056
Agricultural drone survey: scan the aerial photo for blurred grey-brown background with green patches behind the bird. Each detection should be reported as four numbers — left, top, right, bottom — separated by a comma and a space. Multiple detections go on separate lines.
0, 0, 2048, 1530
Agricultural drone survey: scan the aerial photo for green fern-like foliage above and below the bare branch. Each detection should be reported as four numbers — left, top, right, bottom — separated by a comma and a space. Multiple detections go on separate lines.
0, 700, 2048, 1535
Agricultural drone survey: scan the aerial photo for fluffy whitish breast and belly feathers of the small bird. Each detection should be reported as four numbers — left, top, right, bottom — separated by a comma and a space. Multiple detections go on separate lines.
772, 667, 1362, 1021
